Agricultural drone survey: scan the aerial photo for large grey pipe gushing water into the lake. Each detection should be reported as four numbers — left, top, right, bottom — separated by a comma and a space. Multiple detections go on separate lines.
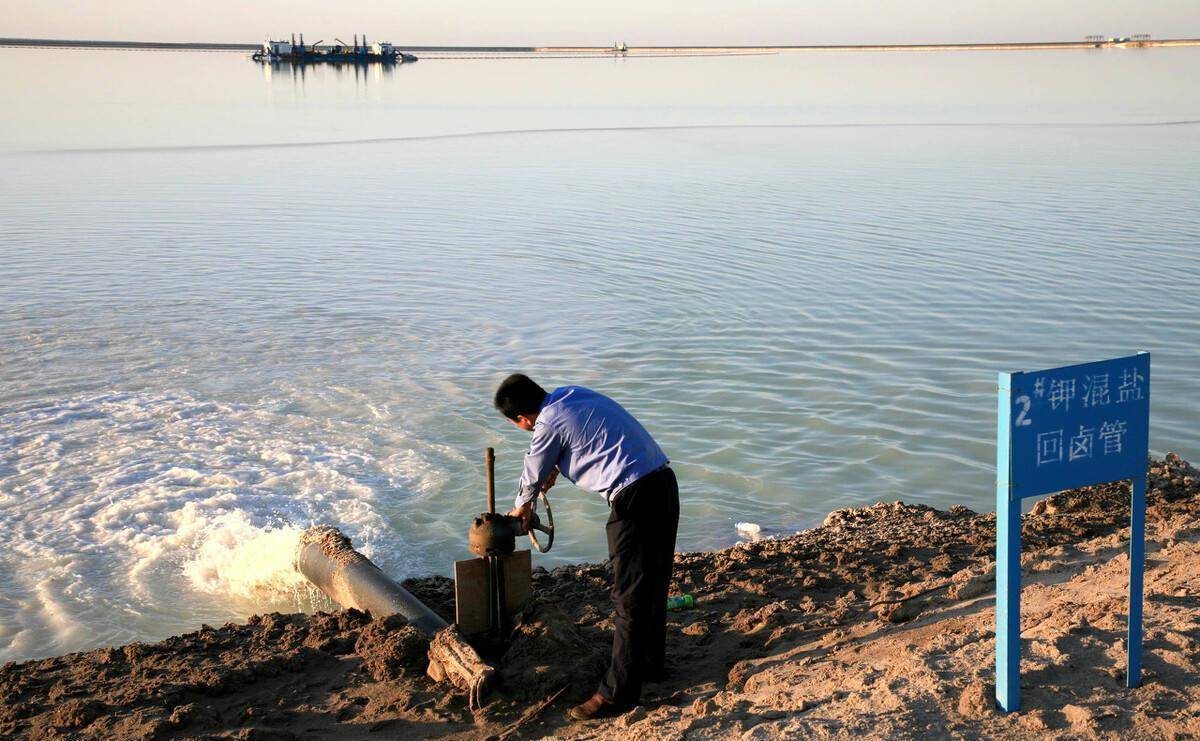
296, 525, 448, 635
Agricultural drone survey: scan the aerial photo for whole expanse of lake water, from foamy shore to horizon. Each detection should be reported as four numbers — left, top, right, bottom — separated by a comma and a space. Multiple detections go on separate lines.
0, 49, 1200, 659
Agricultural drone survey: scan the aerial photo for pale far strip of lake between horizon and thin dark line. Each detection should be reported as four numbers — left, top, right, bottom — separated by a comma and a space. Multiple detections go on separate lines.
0, 48, 1200, 152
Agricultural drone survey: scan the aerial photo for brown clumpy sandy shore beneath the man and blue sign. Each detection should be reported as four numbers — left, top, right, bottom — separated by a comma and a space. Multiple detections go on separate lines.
0, 456, 1200, 739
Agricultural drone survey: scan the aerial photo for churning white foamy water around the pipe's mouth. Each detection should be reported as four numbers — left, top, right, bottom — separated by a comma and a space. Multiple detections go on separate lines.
0, 392, 427, 662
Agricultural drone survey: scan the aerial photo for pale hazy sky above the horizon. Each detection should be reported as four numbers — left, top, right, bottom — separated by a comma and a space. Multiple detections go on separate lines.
0, 0, 1200, 46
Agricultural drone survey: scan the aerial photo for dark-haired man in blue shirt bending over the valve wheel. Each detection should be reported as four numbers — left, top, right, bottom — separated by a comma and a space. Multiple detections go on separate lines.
496, 374, 679, 721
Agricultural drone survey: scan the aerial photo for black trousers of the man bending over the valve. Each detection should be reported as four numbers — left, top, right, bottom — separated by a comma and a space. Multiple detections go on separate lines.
599, 468, 679, 705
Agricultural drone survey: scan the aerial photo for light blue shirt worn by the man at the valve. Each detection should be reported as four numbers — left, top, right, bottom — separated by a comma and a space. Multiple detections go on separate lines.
516, 386, 670, 507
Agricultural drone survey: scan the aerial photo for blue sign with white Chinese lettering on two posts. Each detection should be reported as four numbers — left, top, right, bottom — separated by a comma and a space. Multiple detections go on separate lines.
996, 353, 1150, 712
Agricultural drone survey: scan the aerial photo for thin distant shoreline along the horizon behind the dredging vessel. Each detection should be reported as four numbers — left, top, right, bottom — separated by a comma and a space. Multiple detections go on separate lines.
7, 38, 1200, 56
